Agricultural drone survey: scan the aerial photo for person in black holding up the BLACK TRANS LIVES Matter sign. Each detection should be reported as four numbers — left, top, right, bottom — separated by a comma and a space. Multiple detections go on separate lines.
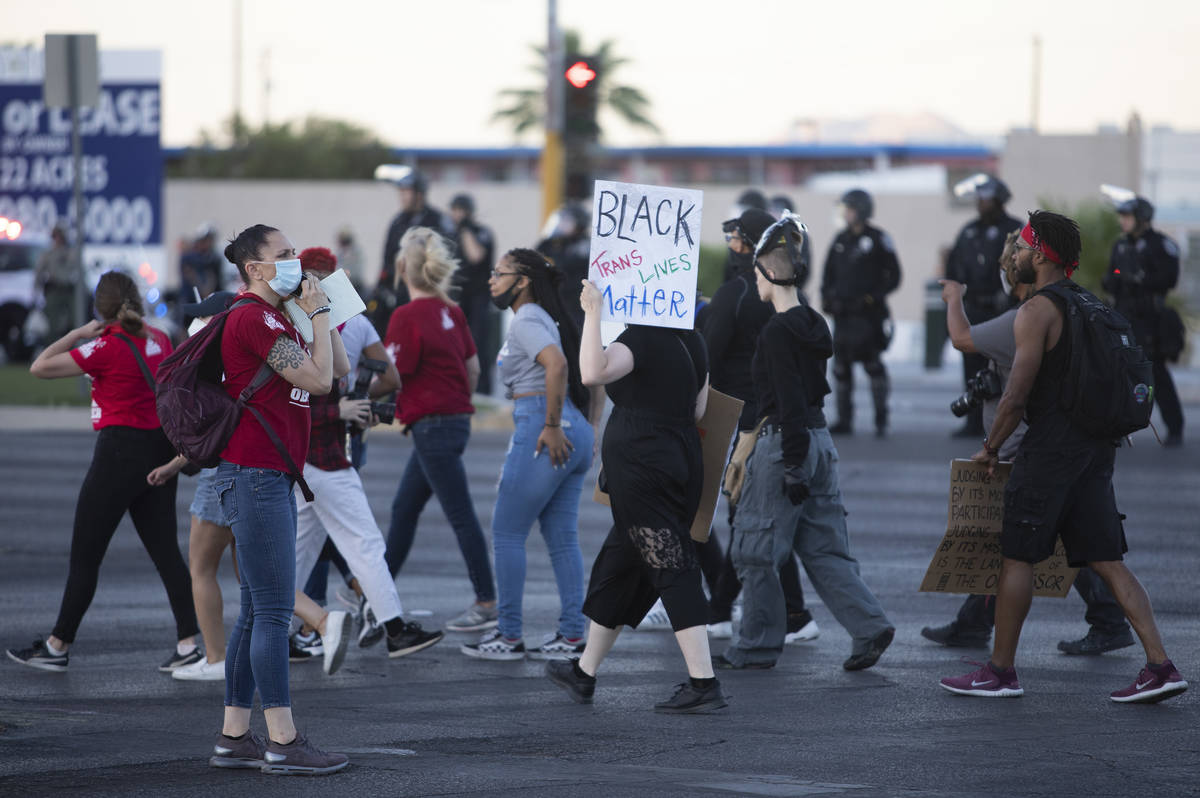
546, 281, 726, 713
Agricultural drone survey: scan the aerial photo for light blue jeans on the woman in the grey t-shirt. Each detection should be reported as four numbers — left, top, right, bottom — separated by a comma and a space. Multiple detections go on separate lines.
492, 396, 594, 640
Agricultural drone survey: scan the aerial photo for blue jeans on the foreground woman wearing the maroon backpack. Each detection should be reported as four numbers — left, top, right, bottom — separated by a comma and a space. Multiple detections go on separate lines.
216, 461, 296, 709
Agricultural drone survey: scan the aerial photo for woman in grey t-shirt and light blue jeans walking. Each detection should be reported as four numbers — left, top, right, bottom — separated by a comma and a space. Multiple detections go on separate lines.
462, 250, 594, 660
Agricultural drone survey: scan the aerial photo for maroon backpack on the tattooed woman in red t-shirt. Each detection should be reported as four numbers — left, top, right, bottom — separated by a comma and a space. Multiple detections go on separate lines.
155, 299, 313, 502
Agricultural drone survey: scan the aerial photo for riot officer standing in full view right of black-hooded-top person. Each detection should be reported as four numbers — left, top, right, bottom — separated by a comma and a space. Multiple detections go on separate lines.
821, 188, 900, 437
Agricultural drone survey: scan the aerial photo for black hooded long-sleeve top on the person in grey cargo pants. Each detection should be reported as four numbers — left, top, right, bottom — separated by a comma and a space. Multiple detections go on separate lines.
754, 305, 833, 466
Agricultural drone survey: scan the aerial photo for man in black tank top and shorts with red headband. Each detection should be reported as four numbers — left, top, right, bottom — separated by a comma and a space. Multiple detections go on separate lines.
941, 211, 1188, 703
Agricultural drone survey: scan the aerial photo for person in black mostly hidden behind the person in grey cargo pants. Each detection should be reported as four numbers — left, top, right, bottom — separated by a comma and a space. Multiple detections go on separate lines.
700, 208, 820, 642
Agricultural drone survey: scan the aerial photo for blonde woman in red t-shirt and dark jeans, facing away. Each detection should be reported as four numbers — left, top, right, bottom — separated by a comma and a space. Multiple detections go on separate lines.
384, 227, 497, 631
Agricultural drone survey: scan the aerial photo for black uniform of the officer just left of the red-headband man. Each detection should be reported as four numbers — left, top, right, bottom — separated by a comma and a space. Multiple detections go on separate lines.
946, 212, 1021, 436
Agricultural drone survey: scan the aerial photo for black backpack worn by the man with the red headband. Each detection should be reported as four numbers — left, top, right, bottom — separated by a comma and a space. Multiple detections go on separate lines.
1038, 280, 1154, 440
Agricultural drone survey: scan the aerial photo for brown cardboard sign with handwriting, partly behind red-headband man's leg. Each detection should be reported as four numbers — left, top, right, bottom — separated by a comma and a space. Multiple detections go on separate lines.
920, 460, 1079, 599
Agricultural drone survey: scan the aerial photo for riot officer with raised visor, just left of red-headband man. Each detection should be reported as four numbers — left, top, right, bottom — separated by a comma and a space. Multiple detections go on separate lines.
946, 174, 1021, 438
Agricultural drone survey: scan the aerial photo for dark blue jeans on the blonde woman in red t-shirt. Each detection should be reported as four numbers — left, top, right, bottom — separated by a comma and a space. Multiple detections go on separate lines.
388, 415, 496, 601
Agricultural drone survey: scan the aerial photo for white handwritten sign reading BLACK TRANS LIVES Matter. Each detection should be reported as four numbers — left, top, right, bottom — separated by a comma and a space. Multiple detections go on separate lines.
588, 180, 704, 330
